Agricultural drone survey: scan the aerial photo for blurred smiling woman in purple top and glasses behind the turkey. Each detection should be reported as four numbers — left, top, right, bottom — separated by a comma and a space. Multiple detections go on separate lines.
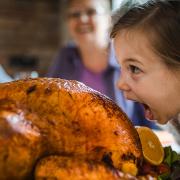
47, 0, 156, 128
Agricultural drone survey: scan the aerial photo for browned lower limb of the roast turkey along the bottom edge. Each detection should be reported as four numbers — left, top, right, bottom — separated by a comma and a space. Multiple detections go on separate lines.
35, 156, 137, 180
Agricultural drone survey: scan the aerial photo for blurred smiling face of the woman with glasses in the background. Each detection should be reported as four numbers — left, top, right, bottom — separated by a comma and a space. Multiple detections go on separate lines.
67, 0, 109, 45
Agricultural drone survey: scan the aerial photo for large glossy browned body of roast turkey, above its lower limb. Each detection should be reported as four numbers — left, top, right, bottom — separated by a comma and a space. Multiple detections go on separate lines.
0, 78, 142, 179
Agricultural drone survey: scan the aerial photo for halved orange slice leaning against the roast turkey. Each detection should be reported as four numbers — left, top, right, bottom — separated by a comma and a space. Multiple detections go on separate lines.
136, 127, 164, 165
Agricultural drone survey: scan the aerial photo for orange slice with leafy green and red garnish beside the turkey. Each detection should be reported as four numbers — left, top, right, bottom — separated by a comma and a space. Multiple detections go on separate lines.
137, 127, 180, 180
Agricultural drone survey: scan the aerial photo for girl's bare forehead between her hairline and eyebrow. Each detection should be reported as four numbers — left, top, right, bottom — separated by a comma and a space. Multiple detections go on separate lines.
114, 30, 165, 65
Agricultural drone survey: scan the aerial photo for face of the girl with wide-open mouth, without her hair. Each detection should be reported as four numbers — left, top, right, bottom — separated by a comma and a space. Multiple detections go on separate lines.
114, 30, 180, 124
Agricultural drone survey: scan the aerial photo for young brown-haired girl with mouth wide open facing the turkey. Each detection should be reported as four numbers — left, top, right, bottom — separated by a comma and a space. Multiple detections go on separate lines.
111, 0, 180, 141
